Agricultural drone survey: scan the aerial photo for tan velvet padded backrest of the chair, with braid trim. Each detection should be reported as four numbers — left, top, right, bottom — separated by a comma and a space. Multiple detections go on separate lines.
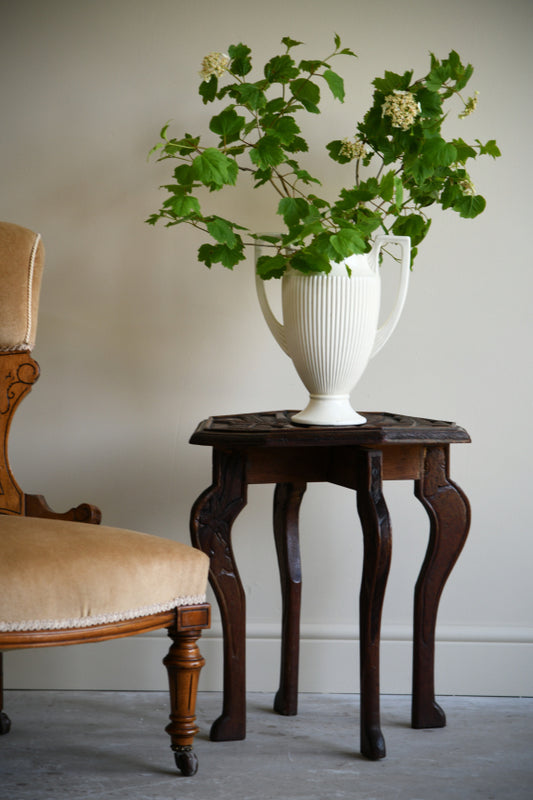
0, 222, 44, 353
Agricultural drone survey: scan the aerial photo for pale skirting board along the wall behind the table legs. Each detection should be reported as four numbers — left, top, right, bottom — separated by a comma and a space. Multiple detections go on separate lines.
4, 625, 533, 696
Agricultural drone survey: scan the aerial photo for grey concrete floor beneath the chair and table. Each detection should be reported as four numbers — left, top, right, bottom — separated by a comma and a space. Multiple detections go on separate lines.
0, 691, 533, 800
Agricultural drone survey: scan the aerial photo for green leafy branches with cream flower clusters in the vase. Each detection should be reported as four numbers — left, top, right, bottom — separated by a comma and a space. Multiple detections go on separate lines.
147, 35, 500, 279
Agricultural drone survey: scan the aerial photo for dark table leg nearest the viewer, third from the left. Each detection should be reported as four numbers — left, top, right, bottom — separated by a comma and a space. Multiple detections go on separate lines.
357, 450, 392, 761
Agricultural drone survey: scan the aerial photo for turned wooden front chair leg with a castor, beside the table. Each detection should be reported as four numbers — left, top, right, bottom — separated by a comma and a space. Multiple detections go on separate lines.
163, 627, 205, 775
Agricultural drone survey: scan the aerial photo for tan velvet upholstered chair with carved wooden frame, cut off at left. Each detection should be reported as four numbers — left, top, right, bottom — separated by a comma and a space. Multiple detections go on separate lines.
0, 222, 210, 775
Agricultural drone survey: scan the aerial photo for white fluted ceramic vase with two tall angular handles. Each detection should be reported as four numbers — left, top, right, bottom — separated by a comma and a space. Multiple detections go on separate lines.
256, 236, 411, 425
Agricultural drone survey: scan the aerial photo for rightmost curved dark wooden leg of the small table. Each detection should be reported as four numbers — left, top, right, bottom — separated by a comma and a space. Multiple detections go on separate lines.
411, 445, 470, 728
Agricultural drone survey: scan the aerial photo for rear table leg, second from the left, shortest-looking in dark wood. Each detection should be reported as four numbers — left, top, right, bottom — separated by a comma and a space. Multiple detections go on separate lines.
274, 483, 307, 716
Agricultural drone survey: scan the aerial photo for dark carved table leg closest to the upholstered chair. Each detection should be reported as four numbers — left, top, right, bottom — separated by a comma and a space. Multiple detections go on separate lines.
191, 450, 247, 742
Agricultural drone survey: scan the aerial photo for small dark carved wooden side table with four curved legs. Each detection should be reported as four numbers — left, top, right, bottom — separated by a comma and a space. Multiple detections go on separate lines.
190, 411, 470, 759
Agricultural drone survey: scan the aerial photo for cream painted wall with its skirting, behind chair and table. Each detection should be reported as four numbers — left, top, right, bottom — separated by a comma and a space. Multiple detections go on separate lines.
0, 0, 533, 694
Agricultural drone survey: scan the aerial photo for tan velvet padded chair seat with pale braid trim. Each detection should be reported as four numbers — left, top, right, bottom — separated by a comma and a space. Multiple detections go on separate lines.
0, 515, 209, 632
